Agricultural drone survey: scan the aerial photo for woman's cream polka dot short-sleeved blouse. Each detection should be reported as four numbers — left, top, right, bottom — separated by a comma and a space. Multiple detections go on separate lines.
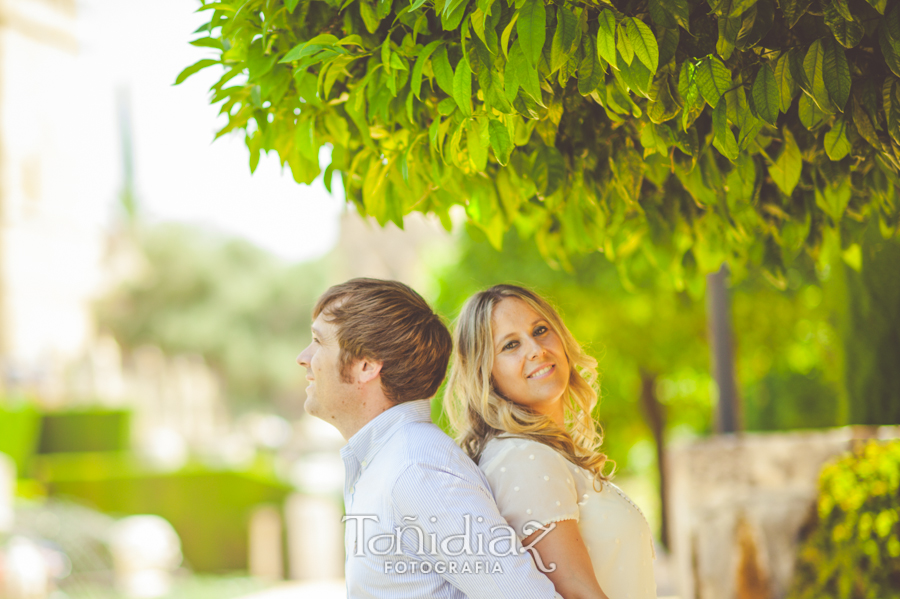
479, 437, 656, 599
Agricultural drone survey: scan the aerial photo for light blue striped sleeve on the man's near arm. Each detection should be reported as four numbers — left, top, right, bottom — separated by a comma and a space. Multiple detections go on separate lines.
392, 464, 562, 599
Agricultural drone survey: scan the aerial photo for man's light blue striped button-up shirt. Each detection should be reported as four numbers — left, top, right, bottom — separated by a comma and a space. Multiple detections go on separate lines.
341, 399, 561, 599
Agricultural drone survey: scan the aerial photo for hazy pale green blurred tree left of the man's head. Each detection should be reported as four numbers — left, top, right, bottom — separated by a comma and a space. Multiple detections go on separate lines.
97, 225, 325, 409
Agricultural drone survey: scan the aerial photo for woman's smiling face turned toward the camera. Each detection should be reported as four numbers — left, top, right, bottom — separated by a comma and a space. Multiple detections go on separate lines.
491, 297, 569, 425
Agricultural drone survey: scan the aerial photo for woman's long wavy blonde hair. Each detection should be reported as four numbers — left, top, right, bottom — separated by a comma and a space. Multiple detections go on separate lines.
445, 285, 609, 481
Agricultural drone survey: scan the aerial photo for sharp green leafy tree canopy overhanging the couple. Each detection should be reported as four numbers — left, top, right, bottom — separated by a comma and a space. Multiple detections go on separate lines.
183, 0, 900, 287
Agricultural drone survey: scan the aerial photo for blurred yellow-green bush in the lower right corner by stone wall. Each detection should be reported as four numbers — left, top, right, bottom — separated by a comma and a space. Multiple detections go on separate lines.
790, 441, 900, 599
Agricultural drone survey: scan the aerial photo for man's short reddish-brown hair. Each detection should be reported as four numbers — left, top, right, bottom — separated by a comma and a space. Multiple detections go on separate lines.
313, 278, 453, 403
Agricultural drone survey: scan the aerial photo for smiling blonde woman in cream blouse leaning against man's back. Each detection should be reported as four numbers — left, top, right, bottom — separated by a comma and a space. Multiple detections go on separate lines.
447, 285, 656, 599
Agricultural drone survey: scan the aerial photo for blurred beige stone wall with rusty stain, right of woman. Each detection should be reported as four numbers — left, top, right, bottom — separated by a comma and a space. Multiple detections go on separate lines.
667, 427, 900, 599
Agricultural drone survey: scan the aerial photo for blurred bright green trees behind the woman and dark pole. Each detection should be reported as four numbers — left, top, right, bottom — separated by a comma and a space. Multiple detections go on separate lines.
428, 226, 848, 534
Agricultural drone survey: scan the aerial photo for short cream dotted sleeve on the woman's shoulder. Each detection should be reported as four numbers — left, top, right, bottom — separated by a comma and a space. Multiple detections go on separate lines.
481, 439, 579, 540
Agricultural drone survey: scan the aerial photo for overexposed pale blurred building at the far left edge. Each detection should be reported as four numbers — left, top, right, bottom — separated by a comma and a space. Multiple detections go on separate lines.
0, 0, 116, 402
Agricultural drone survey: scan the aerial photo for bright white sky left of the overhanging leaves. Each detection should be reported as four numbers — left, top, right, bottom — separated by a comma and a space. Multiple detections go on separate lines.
79, 0, 344, 260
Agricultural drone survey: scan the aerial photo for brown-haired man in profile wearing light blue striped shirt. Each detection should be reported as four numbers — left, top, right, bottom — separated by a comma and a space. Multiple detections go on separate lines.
297, 279, 559, 599
